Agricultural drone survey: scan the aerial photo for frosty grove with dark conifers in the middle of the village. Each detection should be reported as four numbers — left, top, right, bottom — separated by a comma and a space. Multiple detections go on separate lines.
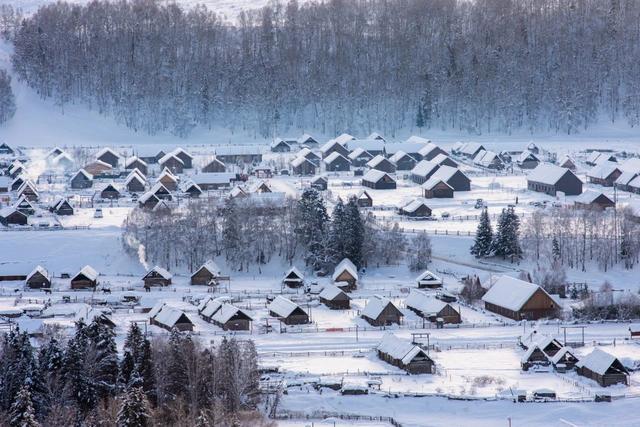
123, 188, 431, 272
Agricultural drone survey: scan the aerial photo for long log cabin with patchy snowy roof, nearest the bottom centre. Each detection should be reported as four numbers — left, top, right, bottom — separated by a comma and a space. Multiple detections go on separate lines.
376, 332, 435, 374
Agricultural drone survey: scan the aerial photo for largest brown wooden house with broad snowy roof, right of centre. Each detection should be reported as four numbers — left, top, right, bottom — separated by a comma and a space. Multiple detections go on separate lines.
482, 276, 560, 320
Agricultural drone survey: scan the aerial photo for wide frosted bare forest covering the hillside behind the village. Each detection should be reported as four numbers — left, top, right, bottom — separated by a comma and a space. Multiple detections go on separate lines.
8, 0, 640, 136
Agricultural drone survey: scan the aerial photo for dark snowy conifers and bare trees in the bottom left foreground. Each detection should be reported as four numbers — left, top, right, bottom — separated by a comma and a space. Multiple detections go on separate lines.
0, 318, 263, 427
